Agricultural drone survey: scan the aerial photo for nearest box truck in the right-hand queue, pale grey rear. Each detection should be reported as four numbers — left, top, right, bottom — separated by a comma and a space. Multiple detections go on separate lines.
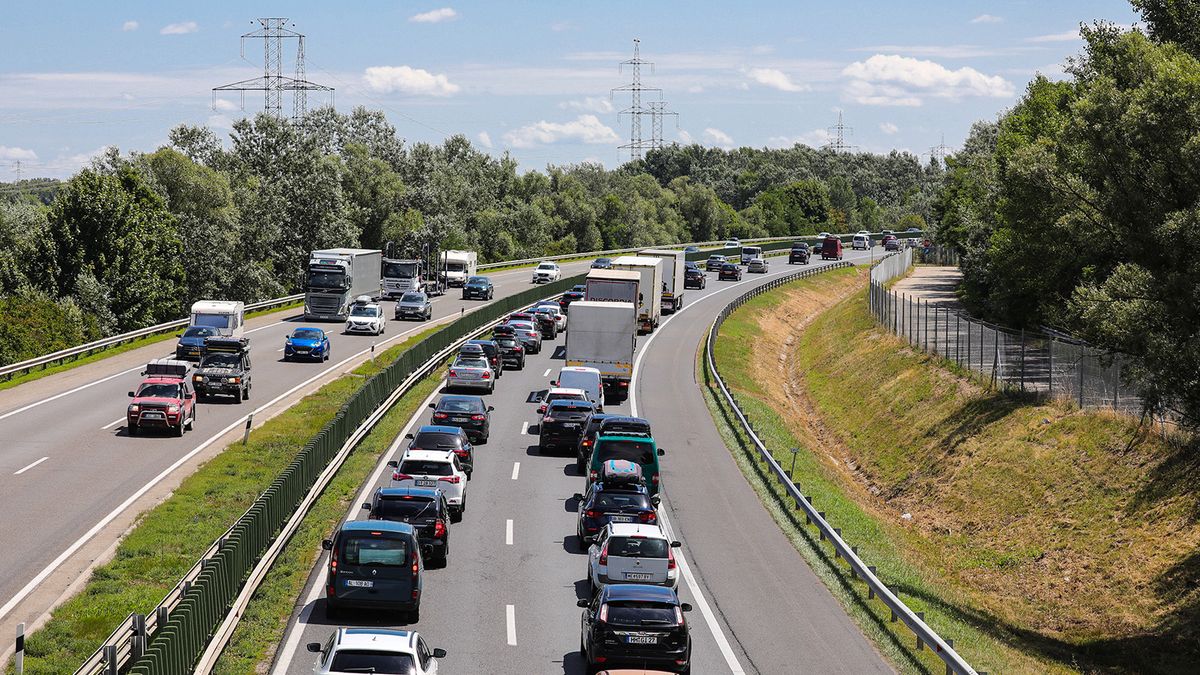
566, 300, 638, 404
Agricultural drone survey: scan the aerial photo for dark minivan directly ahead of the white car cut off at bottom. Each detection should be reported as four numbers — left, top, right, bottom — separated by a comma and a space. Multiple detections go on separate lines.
322, 520, 425, 623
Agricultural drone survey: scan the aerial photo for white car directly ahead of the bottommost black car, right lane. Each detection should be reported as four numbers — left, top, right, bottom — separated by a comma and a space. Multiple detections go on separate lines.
588, 522, 679, 595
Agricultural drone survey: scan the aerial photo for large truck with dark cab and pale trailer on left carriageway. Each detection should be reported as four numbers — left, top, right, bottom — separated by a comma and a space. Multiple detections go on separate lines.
304, 249, 383, 321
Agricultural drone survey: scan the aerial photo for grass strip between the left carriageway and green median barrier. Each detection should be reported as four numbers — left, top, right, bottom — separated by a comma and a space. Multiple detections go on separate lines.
8, 325, 440, 675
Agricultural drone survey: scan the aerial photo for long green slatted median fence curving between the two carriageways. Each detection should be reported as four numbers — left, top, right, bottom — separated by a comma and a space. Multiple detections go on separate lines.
120, 275, 583, 675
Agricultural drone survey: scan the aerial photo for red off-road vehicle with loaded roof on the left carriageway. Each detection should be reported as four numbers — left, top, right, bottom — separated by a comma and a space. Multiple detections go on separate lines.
125, 359, 196, 436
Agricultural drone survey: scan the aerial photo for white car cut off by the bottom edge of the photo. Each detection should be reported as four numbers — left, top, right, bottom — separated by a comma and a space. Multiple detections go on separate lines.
308, 628, 446, 675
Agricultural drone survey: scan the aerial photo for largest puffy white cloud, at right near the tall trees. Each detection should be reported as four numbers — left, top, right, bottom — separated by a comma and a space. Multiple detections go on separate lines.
842, 54, 1015, 106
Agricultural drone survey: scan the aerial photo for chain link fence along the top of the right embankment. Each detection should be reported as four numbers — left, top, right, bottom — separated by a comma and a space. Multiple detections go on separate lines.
868, 249, 1142, 414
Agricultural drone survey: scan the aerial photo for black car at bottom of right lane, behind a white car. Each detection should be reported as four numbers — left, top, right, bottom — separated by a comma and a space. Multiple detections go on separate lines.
577, 584, 691, 673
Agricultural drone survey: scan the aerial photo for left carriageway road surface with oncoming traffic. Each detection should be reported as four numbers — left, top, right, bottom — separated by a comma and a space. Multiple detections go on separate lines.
0, 257, 597, 638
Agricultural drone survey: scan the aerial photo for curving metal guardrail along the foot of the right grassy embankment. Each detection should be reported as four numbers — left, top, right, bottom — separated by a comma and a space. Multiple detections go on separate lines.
704, 262, 986, 675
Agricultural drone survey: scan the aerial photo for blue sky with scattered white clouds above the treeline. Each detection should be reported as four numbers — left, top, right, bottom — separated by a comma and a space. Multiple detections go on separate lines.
0, 0, 1138, 181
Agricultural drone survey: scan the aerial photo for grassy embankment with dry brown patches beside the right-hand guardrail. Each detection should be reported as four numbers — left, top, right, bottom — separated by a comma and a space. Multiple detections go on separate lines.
709, 265, 1200, 673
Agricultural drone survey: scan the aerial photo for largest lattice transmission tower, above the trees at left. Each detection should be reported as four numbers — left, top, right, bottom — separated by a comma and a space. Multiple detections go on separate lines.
212, 17, 334, 123
